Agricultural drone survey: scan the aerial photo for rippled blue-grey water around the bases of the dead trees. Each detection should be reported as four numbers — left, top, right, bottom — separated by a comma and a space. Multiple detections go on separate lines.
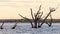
0, 23, 60, 34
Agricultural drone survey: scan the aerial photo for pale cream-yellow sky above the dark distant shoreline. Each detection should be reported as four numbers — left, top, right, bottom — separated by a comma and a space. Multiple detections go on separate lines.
0, 0, 60, 19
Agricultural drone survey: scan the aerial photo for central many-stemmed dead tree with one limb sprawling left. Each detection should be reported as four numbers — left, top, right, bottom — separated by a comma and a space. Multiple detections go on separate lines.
19, 5, 42, 28
